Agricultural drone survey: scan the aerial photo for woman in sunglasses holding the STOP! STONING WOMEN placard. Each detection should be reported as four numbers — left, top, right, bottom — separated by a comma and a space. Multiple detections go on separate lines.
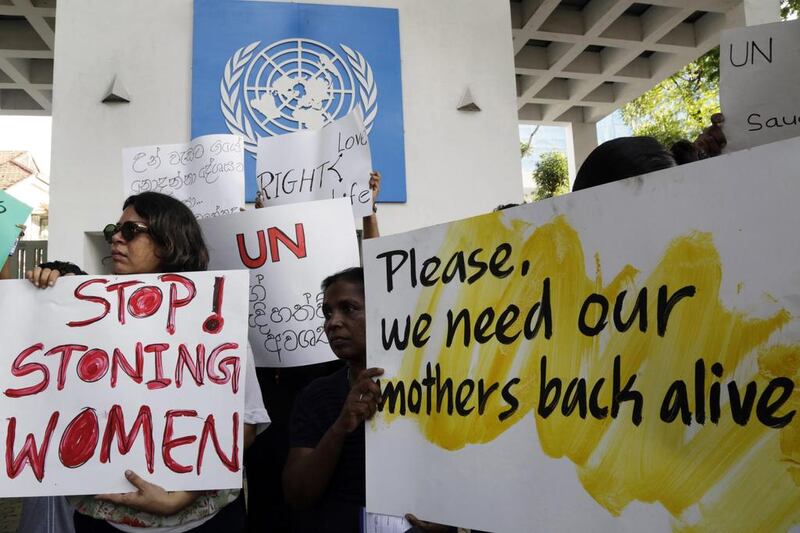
28, 192, 269, 533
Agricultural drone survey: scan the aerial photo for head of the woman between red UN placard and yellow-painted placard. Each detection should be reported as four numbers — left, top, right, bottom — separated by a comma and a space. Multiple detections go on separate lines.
322, 267, 367, 367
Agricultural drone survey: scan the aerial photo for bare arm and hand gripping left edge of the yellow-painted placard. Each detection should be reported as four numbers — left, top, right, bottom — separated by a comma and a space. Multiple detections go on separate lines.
283, 368, 383, 509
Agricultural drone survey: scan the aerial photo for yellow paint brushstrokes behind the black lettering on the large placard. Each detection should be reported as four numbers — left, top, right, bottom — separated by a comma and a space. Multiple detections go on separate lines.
383, 214, 800, 531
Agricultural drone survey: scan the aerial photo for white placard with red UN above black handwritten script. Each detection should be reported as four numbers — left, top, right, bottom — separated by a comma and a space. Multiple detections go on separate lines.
200, 198, 359, 367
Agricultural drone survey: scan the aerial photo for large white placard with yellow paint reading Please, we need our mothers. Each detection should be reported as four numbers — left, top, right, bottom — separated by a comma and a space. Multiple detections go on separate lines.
364, 139, 800, 532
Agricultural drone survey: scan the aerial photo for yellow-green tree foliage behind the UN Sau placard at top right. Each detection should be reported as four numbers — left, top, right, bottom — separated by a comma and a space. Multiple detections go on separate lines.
621, 0, 800, 148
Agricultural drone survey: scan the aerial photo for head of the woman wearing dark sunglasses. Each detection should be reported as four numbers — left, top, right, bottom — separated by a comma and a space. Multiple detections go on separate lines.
104, 192, 208, 274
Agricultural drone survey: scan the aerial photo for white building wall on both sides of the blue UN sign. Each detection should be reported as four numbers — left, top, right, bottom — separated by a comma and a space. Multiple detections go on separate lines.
49, 0, 522, 272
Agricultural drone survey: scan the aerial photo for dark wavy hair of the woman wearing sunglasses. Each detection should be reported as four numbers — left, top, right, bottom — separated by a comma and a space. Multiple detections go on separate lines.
122, 192, 208, 272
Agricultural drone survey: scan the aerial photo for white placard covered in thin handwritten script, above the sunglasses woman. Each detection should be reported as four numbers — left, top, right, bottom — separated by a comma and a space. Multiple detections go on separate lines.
122, 135, 244, 219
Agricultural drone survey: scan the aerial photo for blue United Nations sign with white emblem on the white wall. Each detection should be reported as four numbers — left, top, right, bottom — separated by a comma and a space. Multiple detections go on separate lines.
191, 0, 406, 202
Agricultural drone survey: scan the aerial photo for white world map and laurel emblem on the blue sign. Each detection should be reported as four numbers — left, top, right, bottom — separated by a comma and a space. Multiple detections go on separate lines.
220, 39, 378, 153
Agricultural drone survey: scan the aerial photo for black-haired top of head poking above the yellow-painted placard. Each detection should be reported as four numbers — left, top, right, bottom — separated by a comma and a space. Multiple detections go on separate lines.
572, 137, 675, 191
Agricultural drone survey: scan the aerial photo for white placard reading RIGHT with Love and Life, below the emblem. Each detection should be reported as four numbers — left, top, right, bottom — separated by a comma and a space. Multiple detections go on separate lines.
256, 110, 372, 217
